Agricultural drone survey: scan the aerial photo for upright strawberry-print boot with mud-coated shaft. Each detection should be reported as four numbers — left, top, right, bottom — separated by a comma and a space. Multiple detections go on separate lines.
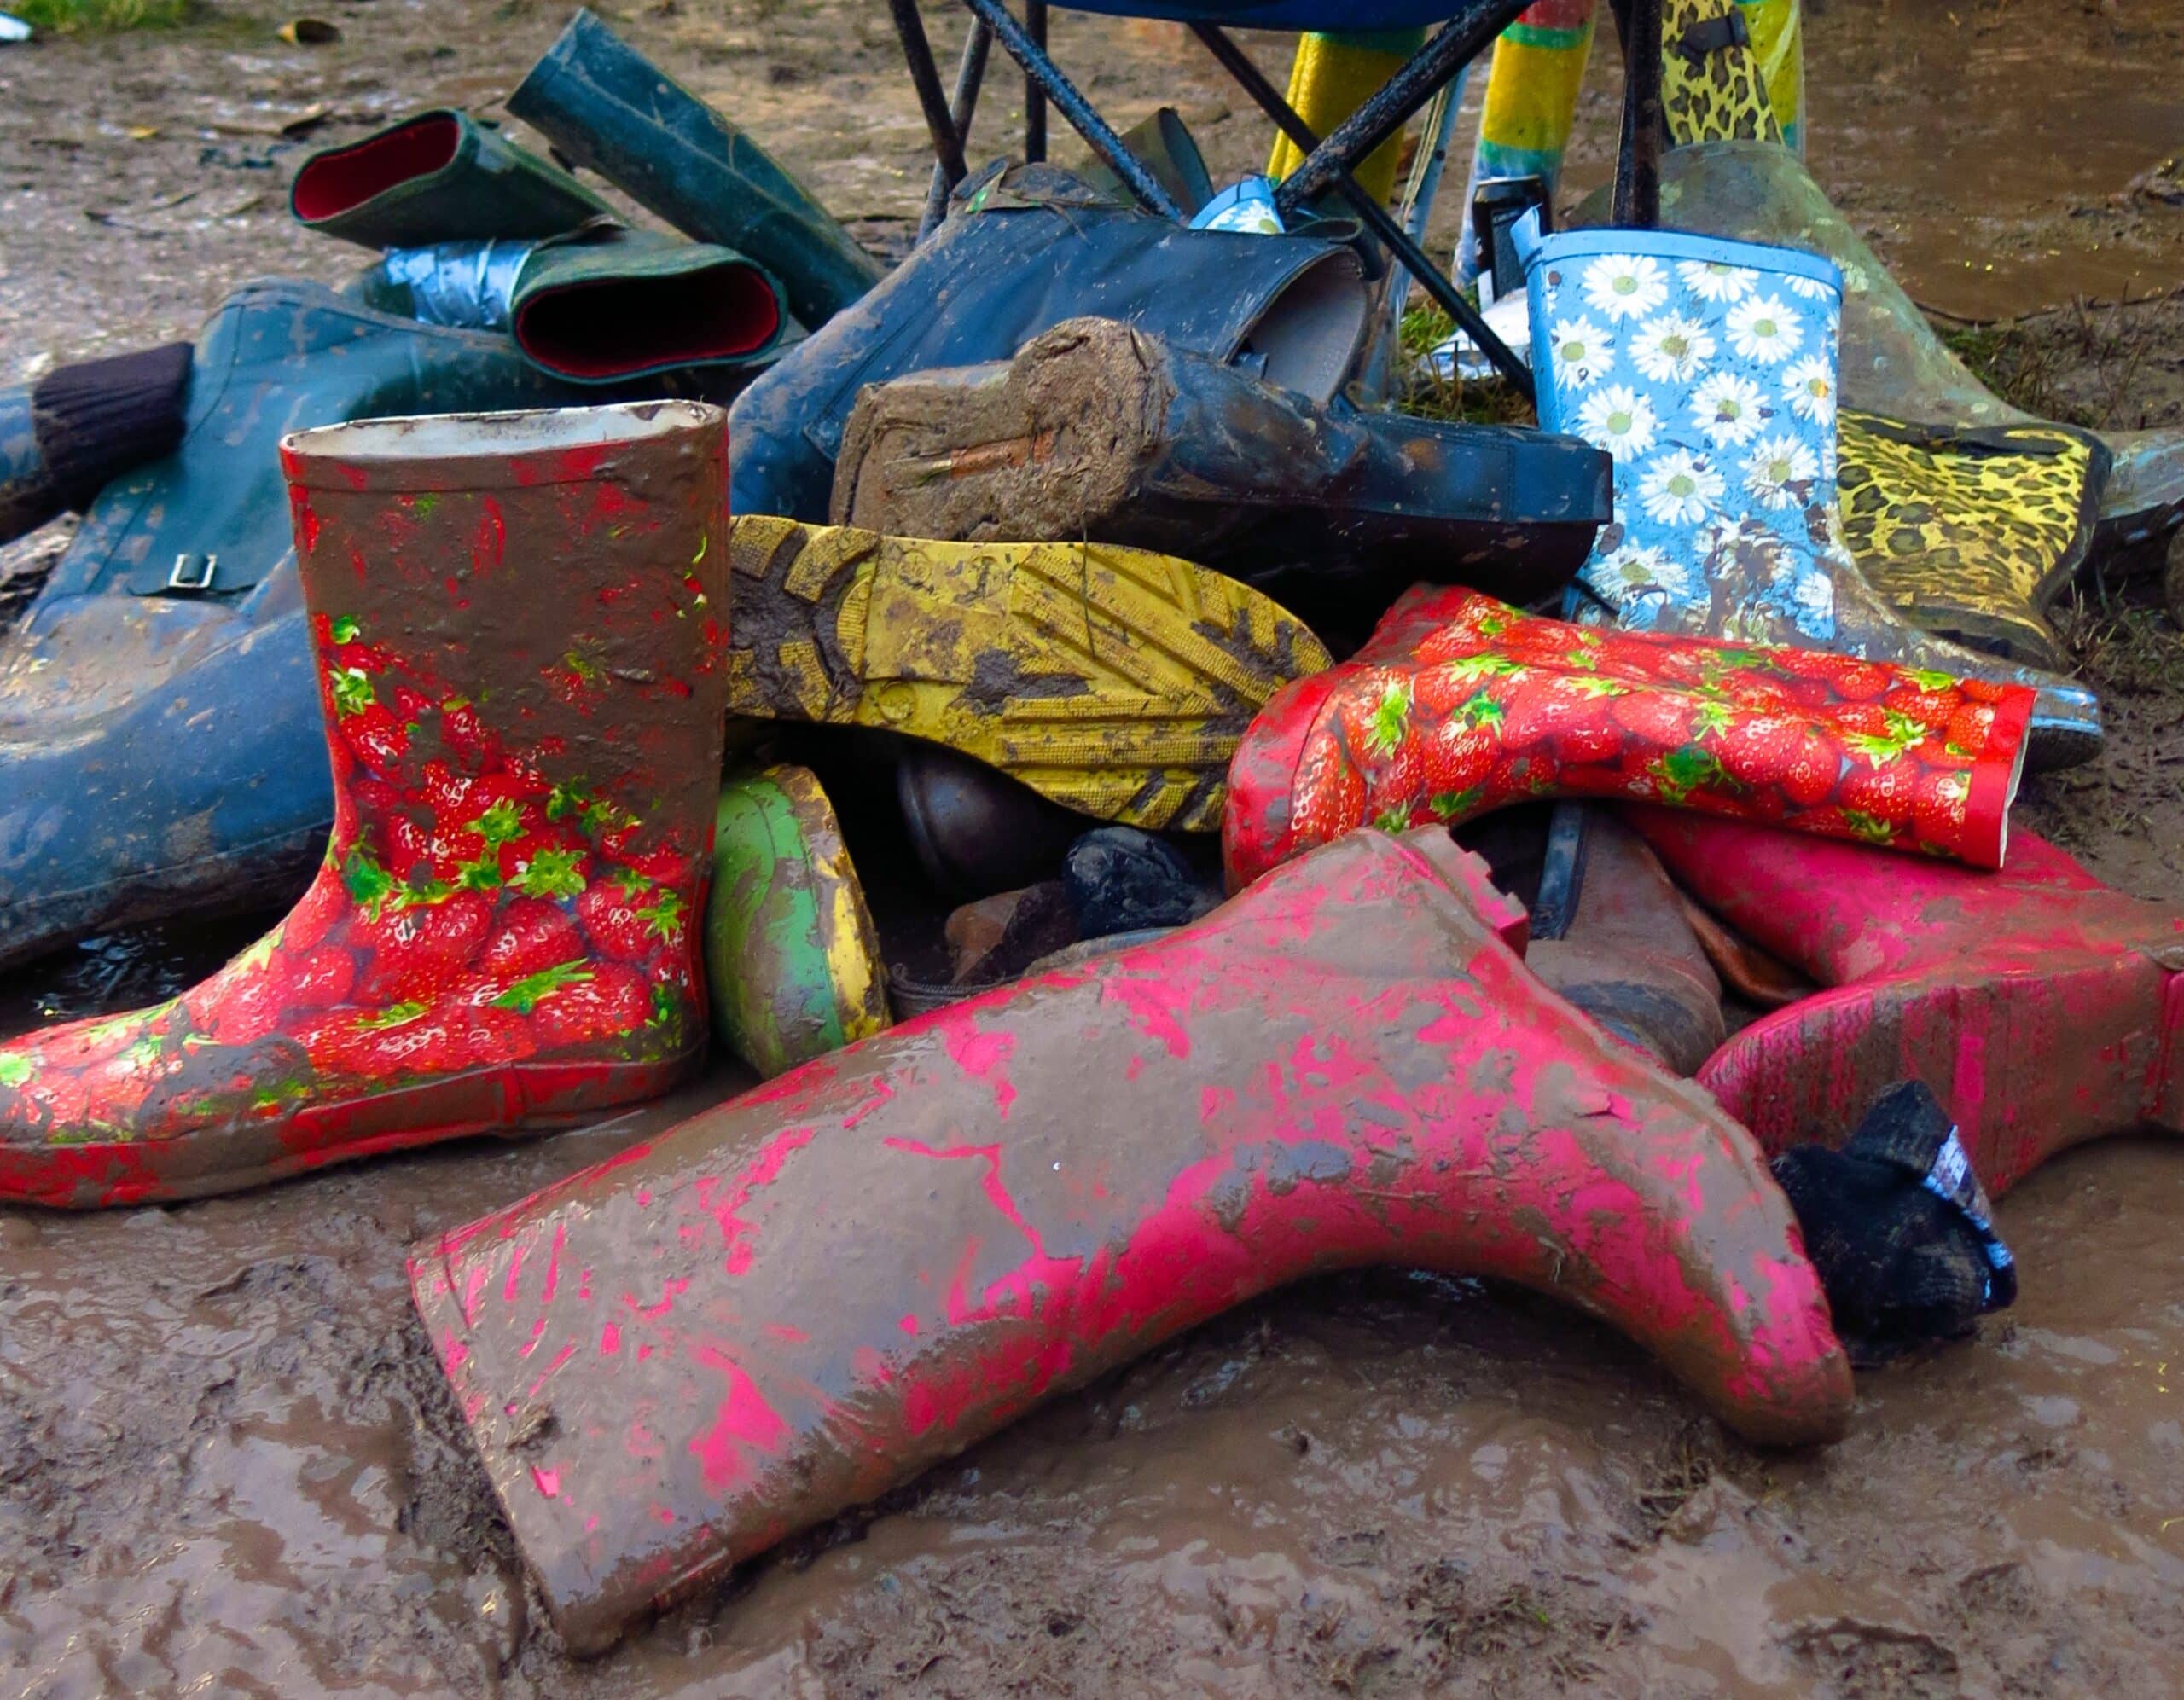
0, 402, 727, 1207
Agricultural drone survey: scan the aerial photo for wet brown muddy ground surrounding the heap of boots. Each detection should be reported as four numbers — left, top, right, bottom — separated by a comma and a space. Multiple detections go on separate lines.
0, 0, 2184, 1696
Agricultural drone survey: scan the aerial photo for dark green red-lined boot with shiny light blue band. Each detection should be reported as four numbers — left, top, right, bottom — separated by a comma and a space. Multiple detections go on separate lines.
356, 227, 802, 384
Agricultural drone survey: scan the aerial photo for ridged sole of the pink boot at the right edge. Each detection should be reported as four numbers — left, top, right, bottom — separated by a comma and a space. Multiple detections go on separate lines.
1699, 951, 2184, 1196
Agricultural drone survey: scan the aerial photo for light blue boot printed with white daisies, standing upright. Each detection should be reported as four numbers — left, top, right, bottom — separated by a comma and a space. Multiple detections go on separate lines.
1518, 216, 2101, 766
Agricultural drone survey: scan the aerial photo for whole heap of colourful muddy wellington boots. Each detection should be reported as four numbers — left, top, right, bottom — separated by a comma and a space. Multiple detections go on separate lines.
0, 0, 2184, 1652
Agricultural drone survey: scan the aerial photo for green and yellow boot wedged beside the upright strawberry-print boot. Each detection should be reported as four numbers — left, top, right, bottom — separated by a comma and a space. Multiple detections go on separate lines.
706, 766, 891, 1080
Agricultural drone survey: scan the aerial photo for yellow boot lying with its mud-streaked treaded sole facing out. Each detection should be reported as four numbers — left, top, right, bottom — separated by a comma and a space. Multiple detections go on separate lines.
727, 515, 1327, 832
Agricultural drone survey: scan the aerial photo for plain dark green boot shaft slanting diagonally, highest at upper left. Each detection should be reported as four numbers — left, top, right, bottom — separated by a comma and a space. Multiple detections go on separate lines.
506, 9, 880, 328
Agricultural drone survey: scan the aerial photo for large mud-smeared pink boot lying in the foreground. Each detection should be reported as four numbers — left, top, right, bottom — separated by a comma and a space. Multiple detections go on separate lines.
410, 832, 1852, 1650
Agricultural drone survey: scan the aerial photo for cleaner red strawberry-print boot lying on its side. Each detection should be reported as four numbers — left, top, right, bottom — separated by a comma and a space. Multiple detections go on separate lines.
1221, 587, 2033, 891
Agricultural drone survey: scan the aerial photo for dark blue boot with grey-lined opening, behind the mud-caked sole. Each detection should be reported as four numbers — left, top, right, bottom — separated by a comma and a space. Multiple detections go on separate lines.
729, 165, 1368, 524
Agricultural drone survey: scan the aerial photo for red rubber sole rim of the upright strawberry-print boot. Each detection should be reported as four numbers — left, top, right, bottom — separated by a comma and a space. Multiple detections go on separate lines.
0, 1050, 703, 1209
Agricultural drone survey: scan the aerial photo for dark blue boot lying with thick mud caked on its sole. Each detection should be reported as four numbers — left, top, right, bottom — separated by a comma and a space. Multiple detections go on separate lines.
832, 319, 1612, 624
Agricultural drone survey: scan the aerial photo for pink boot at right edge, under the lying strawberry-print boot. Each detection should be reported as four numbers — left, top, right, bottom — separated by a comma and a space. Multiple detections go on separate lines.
1631, 809, 2184, 1196
